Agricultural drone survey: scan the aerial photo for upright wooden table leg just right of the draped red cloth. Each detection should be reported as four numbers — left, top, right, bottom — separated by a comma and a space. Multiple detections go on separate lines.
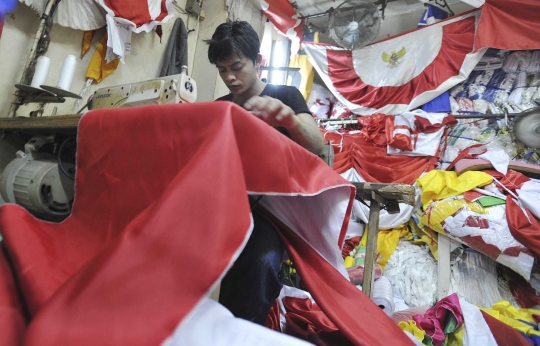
362, 192, 380, 299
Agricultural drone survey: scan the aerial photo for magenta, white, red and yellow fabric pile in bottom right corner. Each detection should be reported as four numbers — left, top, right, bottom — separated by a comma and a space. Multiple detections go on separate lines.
398, 294, 540, 346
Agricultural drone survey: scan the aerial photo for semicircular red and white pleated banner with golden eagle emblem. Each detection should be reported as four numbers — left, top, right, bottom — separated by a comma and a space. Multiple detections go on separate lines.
304, 10, 485, 115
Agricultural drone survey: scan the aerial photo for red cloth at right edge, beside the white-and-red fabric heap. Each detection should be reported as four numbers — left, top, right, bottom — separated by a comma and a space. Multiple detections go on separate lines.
506, 195, 540, 255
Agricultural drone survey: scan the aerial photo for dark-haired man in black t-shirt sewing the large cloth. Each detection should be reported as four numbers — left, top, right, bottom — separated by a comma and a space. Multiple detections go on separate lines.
206, 22, 324, 325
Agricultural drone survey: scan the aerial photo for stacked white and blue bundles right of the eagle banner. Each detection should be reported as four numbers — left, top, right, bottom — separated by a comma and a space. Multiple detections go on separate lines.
450, 49, 540, 114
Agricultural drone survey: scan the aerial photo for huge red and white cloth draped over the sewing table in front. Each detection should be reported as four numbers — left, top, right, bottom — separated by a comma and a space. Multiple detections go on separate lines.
0, 103, 414, 346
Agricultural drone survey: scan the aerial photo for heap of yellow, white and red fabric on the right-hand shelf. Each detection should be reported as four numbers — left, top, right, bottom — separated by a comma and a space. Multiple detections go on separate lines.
415, 171, 540, 280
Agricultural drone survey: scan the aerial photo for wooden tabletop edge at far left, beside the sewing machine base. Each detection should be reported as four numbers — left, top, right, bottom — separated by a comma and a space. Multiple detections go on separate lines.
0, 115, 82, 131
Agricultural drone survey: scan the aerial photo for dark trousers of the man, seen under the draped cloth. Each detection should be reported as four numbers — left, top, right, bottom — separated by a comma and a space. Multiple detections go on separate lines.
219, 209, 285, 325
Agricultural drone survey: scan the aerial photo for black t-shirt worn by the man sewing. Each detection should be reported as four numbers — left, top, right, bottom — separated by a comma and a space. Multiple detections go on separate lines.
216, 84, 311, 138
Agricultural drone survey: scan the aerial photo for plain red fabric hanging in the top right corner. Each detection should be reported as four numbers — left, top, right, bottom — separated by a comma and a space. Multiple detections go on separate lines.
475, 0, 540, 50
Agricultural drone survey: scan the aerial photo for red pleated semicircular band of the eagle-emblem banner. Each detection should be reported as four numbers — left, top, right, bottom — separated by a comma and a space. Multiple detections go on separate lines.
326, 17, 475, 109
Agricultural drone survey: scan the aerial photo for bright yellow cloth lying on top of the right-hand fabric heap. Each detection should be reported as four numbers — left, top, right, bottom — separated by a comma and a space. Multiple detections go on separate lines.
417, 170, 493, 210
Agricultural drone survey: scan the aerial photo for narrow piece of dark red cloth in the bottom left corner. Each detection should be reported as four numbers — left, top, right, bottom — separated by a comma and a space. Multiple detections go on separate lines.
0, 248, 26, 346
